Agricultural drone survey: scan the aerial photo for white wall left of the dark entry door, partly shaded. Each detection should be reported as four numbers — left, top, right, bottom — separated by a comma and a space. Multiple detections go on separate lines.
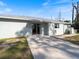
0, 21, 32, 38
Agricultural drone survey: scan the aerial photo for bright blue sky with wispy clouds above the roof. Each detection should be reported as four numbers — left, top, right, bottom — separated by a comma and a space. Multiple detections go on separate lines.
0, 0, 78, 20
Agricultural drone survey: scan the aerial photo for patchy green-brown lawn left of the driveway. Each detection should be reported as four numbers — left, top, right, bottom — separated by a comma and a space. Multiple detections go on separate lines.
0, 37, 33, 59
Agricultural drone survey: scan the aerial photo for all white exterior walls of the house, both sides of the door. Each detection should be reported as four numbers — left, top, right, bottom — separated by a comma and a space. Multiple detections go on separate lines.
0, 21, 75, 38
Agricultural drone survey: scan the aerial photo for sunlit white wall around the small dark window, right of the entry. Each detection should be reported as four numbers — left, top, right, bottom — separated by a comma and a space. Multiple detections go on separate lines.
49, 23, 75, 36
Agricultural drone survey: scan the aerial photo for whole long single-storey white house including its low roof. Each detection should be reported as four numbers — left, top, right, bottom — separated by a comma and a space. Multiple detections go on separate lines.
0, 16, 74, 38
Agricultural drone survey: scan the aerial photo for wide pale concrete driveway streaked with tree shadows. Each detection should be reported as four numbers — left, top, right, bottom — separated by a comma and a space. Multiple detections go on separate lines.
28, 35, 79, 59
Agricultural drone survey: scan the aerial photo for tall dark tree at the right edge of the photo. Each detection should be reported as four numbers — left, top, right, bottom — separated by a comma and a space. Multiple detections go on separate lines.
72, 2, 79, 30
